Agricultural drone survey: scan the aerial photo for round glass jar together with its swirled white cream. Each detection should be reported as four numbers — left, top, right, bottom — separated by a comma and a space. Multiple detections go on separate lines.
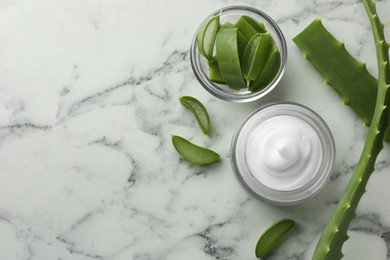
231, 103, 335, 206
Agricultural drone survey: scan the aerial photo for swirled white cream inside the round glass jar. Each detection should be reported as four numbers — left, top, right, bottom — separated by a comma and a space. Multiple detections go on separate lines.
245, 115, 323, 191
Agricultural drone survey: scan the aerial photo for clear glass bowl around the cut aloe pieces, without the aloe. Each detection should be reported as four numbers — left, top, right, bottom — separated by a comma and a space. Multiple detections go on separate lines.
190, 6, 287, 103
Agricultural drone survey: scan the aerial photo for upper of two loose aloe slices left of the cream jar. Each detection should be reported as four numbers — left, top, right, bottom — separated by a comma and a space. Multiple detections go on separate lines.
179, 96, 210, 135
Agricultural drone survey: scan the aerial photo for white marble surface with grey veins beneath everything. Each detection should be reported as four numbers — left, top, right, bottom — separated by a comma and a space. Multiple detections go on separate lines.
0, 0, 390, 260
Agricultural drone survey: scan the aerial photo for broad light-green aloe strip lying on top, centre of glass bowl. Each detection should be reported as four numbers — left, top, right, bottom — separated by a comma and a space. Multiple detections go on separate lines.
215, 27, 246, 90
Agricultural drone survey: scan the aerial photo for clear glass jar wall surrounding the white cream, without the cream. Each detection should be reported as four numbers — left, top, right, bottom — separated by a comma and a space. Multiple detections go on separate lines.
230, 103, 336, 206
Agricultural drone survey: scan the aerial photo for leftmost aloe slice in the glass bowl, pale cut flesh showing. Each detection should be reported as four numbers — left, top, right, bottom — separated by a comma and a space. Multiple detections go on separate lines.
196, 15, 219, 59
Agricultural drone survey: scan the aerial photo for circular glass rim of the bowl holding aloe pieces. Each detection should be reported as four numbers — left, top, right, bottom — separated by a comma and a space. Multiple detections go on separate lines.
190, 5, 287, 103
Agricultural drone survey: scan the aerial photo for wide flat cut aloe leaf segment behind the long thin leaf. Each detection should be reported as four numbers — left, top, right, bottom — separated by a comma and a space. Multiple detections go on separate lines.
293, 19, 378, 125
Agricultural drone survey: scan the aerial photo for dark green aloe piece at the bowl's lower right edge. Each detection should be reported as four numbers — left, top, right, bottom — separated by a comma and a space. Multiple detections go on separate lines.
249, 44, 281, 92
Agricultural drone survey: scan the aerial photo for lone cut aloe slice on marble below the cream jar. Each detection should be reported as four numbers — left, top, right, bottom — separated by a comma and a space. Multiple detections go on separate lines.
255, 219, 295, 258
